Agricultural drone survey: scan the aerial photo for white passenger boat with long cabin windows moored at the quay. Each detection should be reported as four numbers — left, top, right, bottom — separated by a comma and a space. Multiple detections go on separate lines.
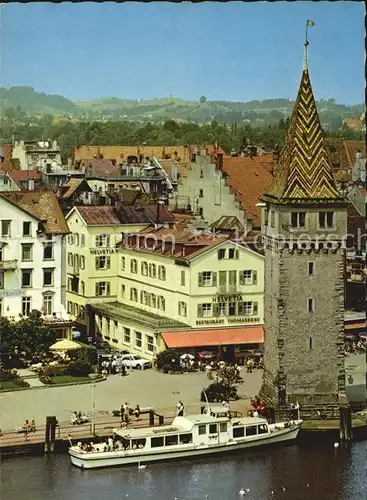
69, 406, 302, 469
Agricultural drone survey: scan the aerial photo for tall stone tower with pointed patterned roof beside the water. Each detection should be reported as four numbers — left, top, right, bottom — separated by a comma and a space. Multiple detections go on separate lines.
261, 46, 347, 406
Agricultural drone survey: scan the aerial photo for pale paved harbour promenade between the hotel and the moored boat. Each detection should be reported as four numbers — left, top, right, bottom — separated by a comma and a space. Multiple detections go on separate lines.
0, 369, 262, 430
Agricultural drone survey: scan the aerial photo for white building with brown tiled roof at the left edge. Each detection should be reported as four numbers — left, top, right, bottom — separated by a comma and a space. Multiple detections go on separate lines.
0, 192, 68, 323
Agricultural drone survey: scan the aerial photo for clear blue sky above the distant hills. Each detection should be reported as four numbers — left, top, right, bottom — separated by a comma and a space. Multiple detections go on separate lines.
0, 2, 365, 104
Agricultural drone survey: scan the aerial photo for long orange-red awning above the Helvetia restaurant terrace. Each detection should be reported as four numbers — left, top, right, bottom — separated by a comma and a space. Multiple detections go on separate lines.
161, 326, 264, 348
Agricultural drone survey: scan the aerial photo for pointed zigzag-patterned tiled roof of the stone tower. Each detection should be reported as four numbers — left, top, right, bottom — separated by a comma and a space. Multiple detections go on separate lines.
264, 69, 343, 203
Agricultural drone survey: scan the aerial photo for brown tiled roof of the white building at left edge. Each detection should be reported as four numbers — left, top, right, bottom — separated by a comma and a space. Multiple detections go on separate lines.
0, 191, 69, 234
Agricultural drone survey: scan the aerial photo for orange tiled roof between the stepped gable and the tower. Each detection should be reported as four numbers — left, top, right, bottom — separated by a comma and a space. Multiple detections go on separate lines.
223, 155, 273, 227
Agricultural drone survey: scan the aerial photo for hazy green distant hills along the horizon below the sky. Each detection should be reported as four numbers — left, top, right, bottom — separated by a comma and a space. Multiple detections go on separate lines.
0, 87, 364, 127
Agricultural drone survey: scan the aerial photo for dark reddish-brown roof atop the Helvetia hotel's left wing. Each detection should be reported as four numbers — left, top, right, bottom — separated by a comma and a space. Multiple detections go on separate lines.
78, 205, 174, 226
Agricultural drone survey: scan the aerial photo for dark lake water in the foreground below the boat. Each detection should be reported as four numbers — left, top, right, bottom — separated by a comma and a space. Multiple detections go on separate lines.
0, 441, 367, 500
